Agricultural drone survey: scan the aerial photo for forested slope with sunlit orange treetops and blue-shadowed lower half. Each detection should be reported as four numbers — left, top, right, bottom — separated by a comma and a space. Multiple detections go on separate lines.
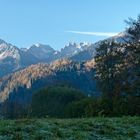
0, 59, 97, 103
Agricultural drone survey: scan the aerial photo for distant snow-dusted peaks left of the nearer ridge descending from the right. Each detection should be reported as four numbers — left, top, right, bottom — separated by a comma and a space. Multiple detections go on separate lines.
0, 40, 91, 77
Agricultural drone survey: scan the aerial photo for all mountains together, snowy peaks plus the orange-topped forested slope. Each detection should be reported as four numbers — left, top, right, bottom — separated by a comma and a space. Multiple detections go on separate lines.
0, 32, 129, 103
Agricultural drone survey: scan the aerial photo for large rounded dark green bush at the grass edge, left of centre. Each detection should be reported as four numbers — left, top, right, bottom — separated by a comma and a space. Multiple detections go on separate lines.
31, 87, 86, 117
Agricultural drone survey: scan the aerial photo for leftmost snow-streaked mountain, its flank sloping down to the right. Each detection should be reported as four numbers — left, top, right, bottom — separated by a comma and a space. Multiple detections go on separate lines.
0, 40, 39, 77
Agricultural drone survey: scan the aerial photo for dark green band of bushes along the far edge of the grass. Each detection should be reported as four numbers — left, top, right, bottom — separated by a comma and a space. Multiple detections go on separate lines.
1, 86, 140, 119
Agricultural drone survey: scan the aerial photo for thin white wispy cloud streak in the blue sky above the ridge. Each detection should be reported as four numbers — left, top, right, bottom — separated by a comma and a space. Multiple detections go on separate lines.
66, 31, 118, 37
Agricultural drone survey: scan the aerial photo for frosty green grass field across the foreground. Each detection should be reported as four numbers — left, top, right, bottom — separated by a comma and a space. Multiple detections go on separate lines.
0, 117, 140, 140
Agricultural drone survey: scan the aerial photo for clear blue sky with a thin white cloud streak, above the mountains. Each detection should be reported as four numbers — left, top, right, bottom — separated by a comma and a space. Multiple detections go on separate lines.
0, 0, 140, 49
